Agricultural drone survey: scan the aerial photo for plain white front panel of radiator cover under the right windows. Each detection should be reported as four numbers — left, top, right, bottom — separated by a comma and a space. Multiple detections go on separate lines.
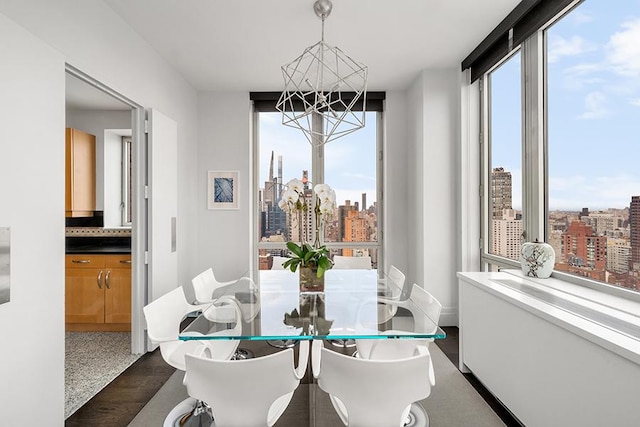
458, 273, 640, 427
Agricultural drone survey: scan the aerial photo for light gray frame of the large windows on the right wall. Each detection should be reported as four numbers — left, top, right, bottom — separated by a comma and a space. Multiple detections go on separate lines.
478, 0, 640, 302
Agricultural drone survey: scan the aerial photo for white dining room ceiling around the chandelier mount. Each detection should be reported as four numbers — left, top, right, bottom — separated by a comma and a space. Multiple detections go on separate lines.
69, 0, 520, 108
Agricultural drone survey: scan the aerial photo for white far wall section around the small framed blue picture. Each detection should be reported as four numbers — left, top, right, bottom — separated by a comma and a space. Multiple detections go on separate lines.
194, 92, 253, 280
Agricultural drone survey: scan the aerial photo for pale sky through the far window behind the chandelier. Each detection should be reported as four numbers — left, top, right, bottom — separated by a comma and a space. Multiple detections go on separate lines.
260, 113, 377, 207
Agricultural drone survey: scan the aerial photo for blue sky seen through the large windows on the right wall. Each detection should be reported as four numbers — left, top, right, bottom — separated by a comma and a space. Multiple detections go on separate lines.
491, 0, 640, 210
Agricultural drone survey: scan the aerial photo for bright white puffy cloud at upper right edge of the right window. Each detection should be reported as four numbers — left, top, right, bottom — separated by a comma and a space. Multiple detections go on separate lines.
607, 19, 640, 77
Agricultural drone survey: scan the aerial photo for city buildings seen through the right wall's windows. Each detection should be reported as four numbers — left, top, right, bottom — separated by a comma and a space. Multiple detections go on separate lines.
489, 167, 640, 291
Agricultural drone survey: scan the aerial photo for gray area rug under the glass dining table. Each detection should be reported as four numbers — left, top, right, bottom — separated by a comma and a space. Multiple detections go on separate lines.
129, 345, 504, 427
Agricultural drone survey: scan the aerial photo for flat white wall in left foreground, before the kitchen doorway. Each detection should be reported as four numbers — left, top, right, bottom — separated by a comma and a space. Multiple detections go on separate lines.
0, 10, 64, 426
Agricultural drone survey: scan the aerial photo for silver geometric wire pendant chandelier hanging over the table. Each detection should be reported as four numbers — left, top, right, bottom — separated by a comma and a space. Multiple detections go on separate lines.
276, 0, 367, 145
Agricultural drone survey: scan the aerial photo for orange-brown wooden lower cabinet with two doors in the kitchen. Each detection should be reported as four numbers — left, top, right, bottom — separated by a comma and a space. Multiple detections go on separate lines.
65, 255, 131, 331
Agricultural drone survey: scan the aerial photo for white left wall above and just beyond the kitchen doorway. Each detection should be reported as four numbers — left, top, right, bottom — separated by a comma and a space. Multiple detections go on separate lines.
0, 0, 197, 288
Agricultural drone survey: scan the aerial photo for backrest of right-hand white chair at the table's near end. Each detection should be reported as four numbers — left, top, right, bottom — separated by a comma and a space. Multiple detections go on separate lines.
311, 340, 431, 427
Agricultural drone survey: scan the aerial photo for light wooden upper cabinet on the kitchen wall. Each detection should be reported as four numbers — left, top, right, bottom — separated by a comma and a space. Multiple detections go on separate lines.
65, 128, 96, 217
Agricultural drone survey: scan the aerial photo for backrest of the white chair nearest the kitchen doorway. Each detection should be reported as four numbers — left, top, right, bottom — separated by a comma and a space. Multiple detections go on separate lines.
142, 287, 193, 344
